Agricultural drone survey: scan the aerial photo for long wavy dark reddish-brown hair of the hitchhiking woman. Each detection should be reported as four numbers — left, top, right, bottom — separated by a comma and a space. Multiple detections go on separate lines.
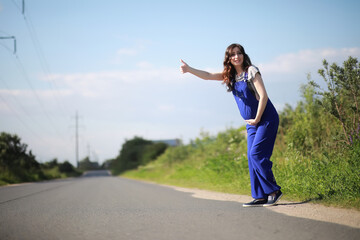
222, 43, 252, 92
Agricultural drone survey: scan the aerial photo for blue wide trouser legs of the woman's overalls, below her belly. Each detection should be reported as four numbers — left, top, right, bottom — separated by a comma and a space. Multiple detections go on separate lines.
246, 120, 280, 199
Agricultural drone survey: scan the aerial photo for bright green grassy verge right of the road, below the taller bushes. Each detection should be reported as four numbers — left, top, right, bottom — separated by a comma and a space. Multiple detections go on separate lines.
123, 128, 360, 209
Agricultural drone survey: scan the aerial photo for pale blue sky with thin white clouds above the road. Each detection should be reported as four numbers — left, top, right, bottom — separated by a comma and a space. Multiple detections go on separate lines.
0, 0, 360, 164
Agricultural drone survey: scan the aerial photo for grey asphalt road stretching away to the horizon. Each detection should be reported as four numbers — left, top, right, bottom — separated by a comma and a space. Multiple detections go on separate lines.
0, 171, 360, 240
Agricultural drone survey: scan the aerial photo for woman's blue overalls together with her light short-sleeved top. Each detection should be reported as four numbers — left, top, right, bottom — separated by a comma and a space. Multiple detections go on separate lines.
233, 66, 280, 199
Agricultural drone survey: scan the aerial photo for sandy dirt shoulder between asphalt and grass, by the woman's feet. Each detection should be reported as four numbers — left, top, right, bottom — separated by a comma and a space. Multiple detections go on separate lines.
172, 186, 360, 228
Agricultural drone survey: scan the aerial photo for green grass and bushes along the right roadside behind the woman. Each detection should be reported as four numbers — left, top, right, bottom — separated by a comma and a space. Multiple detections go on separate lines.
120, 57, 360, 209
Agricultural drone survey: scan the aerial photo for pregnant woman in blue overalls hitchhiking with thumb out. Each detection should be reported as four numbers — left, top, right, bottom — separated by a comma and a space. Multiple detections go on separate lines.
180, 44, 282, 207
